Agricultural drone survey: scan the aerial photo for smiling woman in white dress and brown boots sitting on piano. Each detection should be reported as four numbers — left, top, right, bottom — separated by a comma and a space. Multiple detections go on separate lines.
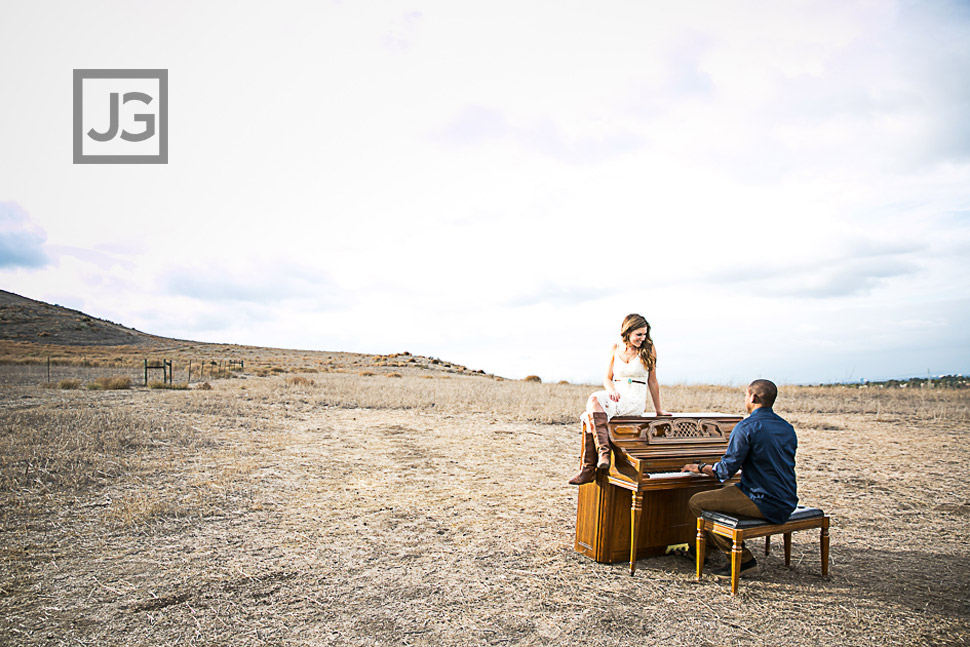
569, 314, 670, 485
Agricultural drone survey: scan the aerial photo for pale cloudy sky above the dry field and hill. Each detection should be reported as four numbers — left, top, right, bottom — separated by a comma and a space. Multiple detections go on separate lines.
0, 0, 970, 385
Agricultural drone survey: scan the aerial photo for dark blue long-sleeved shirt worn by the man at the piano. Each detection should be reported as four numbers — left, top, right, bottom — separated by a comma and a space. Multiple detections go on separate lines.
714, 407, 798, 523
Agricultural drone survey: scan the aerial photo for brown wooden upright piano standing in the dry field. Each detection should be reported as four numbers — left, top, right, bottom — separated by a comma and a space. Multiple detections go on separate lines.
575, 413, 742, 575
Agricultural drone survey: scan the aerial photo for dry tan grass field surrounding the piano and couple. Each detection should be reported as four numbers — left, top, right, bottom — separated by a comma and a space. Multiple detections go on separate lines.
0, 349, 970, 647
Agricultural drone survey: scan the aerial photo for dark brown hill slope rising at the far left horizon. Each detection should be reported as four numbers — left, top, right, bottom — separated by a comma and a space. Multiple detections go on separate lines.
0, 290, 164, 346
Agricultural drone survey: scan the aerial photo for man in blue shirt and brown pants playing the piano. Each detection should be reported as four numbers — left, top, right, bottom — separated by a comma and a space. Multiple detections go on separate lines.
681, 380, 798, 577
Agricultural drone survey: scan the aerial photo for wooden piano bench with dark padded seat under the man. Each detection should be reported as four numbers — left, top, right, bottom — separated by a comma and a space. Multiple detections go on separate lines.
697, 505, 829, 595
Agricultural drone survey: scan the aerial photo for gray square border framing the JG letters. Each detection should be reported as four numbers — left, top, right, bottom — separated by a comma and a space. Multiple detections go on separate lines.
74, 69, 168, 164
